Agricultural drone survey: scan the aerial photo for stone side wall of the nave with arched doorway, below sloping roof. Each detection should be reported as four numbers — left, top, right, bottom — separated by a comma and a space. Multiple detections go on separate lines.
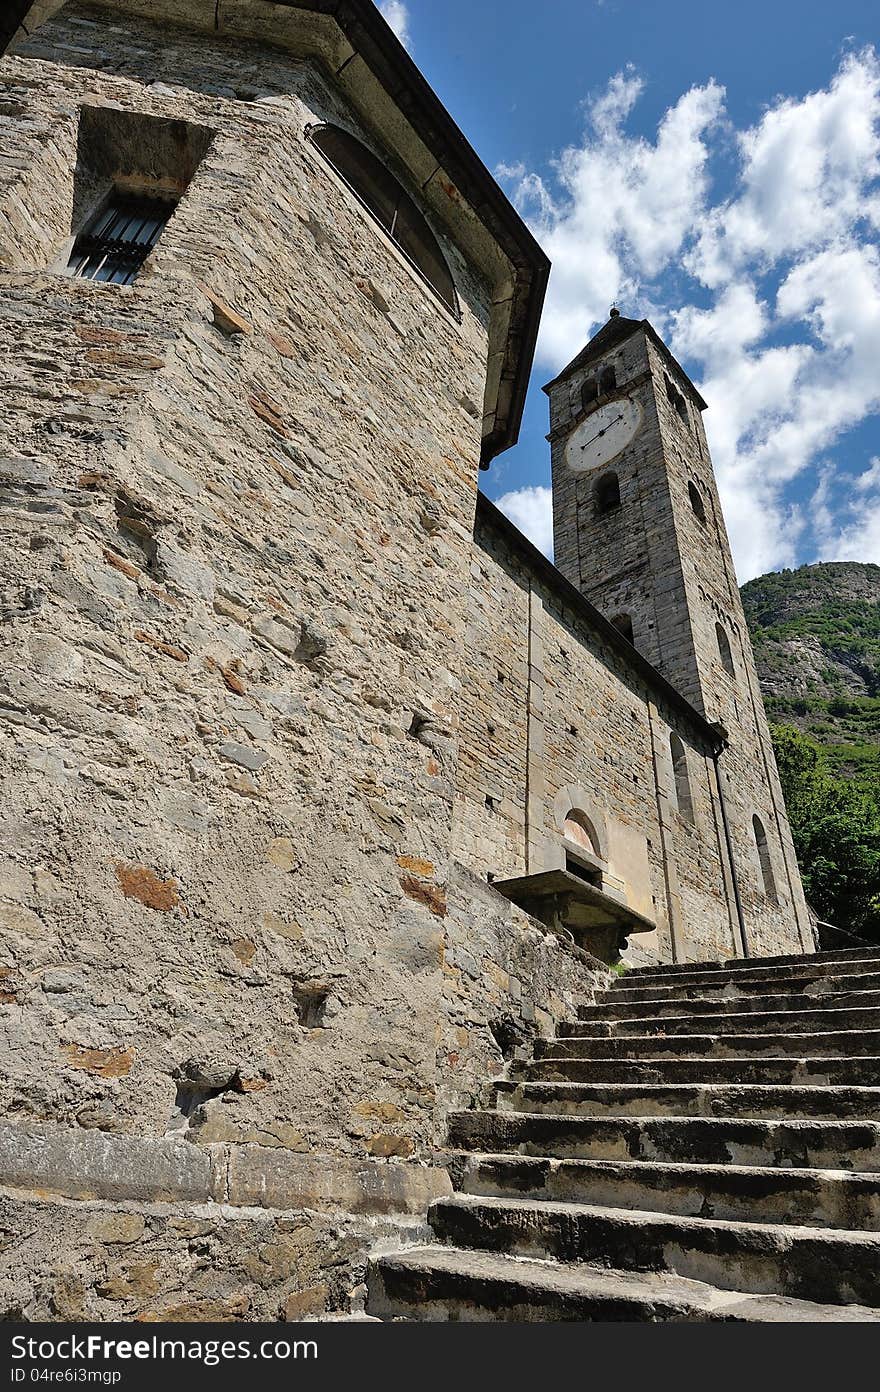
455, 518, 738, 962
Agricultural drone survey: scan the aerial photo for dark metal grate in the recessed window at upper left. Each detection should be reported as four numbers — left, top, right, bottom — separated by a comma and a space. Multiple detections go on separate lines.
67, 196, 174, 285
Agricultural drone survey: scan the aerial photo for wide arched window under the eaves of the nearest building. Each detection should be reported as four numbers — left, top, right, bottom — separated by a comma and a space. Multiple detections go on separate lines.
311, 125, 458, 315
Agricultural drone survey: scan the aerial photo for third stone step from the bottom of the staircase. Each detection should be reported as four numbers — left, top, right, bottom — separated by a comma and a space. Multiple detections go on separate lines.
457, 1155, 880, 1232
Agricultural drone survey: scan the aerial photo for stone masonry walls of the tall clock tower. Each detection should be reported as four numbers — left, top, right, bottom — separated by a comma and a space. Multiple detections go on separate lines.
550, 320, 813, 956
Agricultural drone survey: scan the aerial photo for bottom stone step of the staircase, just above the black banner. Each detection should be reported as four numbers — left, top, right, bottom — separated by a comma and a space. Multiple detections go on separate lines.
366, 1247, 880, 1324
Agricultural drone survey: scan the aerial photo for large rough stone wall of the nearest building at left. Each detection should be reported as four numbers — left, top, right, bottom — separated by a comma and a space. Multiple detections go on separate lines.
0, 7, 604, 1317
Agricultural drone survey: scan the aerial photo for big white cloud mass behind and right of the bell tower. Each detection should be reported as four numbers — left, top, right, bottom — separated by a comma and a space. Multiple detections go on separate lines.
500, 49, 880, 579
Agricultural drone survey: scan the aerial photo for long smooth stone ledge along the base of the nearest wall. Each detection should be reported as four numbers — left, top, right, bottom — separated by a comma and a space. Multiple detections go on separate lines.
0, 1125, 453, 1214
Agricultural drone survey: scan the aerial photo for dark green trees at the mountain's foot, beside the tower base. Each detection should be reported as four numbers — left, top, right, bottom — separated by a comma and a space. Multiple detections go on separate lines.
771, 725, 880, 942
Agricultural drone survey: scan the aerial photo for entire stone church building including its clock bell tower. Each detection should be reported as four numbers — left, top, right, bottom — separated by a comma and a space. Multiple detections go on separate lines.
0, 0, 813, 1320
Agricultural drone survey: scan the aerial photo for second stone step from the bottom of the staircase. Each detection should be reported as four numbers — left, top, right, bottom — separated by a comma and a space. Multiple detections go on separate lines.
427, 1193, 880, 1307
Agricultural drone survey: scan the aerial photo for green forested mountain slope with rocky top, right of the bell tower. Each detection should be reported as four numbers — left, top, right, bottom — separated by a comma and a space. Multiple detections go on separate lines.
742, 561, 880, 941
